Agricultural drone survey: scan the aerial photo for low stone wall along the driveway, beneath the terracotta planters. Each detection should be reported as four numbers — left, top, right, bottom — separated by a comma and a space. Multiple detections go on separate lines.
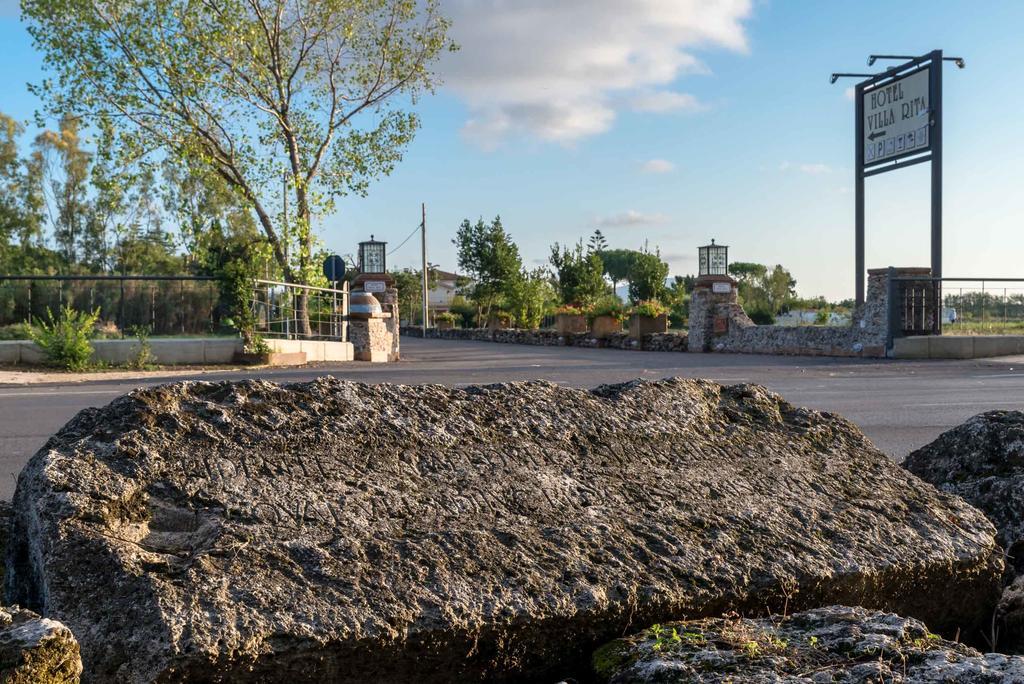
401, 326, 687, 351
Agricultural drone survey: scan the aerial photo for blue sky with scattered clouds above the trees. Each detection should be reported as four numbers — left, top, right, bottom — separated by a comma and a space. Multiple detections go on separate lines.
0, 0, 1024, 298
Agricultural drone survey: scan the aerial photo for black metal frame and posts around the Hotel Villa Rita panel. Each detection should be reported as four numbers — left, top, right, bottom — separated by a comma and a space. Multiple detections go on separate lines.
854, 50, 942, 304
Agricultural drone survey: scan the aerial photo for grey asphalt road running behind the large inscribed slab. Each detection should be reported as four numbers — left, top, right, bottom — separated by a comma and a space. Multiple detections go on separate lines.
0, 338, 1024, 500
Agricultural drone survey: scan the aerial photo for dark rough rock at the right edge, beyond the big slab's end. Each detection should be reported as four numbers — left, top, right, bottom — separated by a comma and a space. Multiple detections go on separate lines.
903, 411, 1024, 652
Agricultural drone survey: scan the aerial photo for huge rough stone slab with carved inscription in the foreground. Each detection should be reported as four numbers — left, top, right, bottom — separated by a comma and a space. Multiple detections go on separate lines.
7, 379, 1002, 683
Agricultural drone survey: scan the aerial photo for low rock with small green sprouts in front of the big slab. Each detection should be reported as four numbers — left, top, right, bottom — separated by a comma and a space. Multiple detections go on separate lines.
593, 606, 1024, 684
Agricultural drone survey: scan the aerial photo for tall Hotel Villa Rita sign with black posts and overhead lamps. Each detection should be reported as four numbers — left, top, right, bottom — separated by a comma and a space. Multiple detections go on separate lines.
851, 50, 946, 304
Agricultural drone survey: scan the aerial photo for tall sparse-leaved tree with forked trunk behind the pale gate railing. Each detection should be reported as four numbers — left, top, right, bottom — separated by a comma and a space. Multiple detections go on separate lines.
22, 0, 451, 332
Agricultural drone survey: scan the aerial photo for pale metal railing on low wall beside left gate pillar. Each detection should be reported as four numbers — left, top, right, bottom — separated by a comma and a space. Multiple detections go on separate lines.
251, 280, 348, 342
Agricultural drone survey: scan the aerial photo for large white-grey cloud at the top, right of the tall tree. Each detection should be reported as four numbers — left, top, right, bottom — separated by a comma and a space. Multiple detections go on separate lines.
441, 0, 752, 147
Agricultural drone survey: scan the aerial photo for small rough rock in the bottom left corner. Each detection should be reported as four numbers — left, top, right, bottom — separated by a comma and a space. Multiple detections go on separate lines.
0, 606, 82, 684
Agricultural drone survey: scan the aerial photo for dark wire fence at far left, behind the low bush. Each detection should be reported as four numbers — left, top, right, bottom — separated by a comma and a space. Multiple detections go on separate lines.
0, 274, 230, 337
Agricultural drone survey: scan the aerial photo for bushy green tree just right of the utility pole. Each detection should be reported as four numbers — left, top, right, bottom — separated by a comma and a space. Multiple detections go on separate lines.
452, 216, 522, 322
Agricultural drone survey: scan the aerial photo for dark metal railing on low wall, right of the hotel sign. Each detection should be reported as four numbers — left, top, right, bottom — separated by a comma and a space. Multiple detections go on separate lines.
889, 276, 1024, 337
